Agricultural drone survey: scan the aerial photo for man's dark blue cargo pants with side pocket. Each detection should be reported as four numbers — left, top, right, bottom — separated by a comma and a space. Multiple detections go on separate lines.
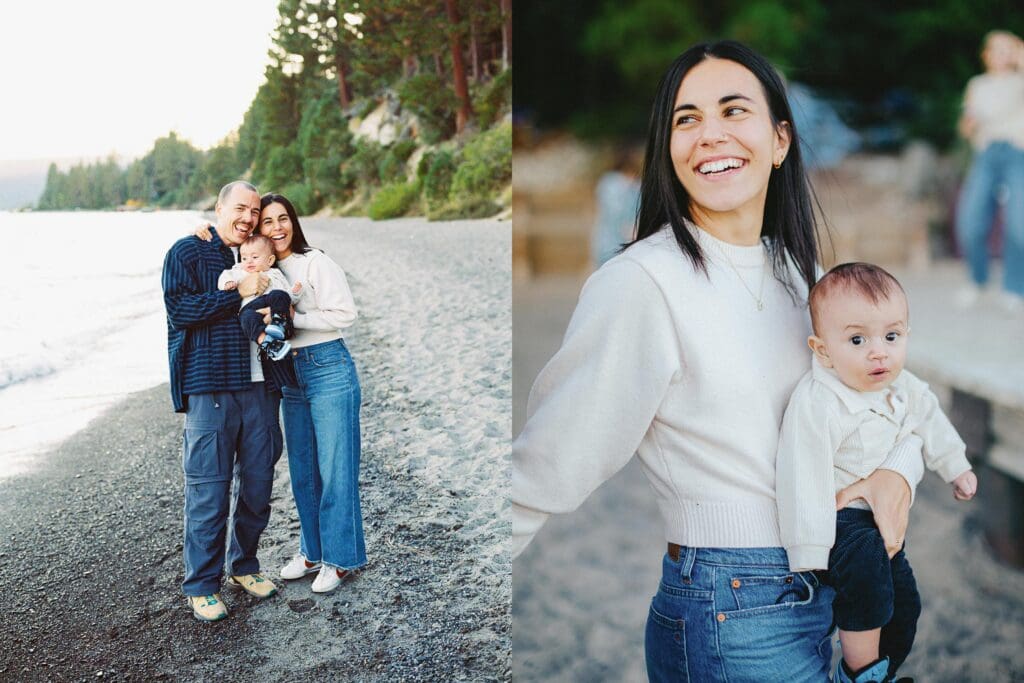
181, 382, 284, 595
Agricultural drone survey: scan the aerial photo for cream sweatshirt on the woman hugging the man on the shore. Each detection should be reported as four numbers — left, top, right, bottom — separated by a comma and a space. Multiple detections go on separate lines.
278, 249, 357, 348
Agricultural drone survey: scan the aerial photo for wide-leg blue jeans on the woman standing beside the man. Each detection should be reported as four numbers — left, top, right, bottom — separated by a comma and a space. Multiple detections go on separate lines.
281, 339, 367, 569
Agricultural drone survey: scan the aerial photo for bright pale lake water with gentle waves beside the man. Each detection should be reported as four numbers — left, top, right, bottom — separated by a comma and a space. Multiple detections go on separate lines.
0, 211, 202, 477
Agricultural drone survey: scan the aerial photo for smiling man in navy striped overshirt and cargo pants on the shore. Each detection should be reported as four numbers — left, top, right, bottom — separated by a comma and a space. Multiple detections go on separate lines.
163, 180, 284, 622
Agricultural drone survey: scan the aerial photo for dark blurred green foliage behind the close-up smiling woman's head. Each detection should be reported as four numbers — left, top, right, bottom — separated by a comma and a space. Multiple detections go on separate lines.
514, 0, 1024, 146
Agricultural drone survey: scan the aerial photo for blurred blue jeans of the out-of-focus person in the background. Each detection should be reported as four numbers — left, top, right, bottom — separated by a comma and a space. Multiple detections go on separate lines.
956, 142, 1024, 296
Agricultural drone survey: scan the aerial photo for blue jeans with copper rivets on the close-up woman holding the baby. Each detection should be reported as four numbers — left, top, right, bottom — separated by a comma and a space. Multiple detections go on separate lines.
645, 547, 835, 683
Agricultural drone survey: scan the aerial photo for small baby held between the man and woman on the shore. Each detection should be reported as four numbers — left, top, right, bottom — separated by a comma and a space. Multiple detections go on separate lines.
217, 234, 302, 360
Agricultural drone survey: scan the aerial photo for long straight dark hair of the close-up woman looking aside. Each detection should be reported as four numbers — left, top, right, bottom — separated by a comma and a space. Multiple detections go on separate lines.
631, 40, 818, 296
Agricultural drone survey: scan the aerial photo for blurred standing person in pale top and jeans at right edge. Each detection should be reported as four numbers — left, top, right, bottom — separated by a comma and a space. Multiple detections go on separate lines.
956, 31, 1024, 311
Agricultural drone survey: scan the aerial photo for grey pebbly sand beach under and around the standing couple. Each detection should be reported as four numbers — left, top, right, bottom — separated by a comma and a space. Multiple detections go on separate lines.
0, 218, 512, 681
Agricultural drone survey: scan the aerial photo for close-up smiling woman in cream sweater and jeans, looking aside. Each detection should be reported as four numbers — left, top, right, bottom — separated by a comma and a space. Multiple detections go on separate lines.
512, 41, 923, 682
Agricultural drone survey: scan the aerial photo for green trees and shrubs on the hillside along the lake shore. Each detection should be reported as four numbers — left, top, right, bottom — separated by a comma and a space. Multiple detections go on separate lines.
37, 0, 511, 217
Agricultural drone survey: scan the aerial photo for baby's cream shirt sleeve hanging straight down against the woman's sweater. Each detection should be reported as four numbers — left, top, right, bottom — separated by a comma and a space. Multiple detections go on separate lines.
775, 377, 842, 571
